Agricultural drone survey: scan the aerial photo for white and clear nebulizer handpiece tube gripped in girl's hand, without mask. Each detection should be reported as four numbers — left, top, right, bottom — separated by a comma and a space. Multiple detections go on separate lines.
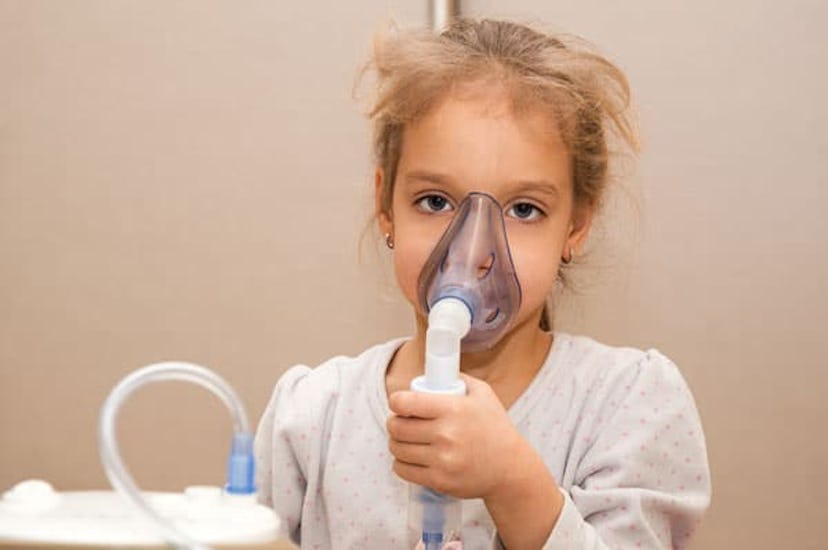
408, 298, 472, 550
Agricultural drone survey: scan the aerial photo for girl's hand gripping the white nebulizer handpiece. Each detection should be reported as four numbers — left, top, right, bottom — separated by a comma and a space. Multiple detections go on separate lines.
388, 375, 535, 498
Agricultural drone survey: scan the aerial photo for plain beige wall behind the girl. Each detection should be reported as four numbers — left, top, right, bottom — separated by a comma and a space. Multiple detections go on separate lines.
0, 0, 828, 550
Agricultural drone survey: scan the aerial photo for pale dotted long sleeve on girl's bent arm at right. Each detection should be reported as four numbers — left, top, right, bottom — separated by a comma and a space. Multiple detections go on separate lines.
544, 351, 710, 550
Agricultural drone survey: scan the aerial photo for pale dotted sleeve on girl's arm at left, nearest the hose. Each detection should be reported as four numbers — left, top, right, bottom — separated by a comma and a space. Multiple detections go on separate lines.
255, 366, 310, 544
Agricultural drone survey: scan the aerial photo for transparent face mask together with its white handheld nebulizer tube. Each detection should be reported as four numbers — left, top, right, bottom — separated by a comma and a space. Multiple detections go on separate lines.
408, 193, 521, 550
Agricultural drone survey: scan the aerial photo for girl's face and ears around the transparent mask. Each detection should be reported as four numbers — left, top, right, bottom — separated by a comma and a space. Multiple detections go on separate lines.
376, 87, 590, 332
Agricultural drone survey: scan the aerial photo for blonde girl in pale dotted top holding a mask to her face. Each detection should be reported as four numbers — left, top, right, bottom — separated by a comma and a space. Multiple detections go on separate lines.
256, 20, 710, 549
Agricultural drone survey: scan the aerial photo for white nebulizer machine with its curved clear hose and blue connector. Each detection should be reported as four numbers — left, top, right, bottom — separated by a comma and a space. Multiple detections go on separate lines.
0, 362, 292, 550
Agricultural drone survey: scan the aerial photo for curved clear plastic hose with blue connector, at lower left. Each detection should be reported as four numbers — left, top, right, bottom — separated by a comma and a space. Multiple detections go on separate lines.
98, 362, 255, 550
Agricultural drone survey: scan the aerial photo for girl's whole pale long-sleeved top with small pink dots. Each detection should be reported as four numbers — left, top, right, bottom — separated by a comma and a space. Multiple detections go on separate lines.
256, 333, 710, 549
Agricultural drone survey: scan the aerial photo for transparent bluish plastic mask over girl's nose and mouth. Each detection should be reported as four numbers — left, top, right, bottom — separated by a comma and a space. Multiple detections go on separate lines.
418, 193, 521, 352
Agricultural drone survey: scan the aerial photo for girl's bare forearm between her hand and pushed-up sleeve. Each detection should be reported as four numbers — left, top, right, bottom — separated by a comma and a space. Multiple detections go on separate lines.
484, 444, 564, 550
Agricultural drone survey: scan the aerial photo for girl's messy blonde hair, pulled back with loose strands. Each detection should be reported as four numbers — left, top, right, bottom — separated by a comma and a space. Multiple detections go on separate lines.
368, 19, 638, 328
